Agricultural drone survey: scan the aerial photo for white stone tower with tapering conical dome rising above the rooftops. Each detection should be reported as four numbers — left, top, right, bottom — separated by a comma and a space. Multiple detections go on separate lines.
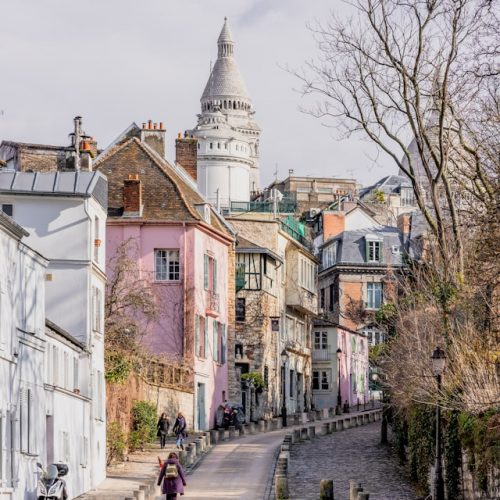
188, 20, 260, 208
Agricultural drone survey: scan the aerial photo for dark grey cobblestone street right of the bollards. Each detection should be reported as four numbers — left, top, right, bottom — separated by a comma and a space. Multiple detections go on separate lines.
288, 422, 417, 500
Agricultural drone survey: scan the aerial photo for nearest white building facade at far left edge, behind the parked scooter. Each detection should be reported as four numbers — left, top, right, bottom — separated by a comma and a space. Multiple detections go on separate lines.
0, 211, 48, 500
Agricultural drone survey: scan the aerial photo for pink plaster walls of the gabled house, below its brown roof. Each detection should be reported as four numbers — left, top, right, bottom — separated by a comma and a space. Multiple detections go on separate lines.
106, 221, 229, 428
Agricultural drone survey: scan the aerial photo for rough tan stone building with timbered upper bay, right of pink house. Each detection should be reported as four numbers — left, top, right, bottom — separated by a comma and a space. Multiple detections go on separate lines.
229, 213, 317, 420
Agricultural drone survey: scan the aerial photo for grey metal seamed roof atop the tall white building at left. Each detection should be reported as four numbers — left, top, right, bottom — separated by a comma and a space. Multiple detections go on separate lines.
0, 171, 107, 209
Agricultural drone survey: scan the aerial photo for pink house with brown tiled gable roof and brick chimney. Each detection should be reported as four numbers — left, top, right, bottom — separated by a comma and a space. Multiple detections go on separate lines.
96, 123, 234, 430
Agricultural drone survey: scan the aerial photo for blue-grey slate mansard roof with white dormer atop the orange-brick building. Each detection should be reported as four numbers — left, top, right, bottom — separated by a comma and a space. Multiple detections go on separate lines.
322, 226, 404, 266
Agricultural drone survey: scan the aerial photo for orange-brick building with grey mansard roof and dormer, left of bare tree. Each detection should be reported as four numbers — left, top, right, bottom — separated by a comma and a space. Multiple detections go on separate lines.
315, 200, 405, 352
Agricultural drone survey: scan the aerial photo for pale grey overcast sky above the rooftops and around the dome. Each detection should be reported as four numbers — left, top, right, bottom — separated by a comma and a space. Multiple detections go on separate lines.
0, 0, 397, 185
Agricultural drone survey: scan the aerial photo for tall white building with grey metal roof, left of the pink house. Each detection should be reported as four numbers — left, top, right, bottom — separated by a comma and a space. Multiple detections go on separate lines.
0, 171, 107, 495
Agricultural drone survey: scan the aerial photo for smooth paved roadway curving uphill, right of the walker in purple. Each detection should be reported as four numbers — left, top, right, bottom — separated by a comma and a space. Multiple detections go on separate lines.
180, 430, 286, 500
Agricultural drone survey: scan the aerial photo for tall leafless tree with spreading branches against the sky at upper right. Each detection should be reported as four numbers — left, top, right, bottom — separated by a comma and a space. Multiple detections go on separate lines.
295, 0, 499, 284
